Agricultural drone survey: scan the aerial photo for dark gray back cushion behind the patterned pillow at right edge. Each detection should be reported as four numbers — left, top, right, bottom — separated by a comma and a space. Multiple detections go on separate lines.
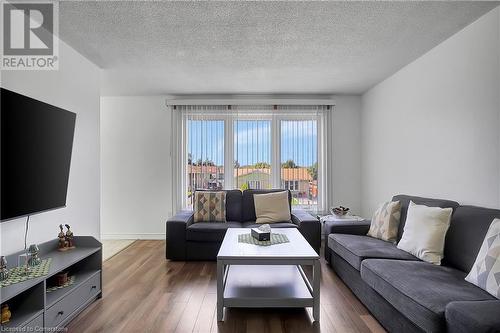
443, 206, 500, 272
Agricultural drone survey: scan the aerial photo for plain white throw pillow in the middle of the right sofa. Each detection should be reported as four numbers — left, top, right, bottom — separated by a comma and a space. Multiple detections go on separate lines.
398, 201, 453, 265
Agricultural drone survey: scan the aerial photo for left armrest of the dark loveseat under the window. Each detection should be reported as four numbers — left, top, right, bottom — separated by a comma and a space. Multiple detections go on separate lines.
165, 210, 194, 260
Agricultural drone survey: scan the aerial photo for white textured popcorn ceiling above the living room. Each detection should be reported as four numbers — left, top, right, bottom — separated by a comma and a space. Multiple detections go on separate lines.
59, 1, 498, 95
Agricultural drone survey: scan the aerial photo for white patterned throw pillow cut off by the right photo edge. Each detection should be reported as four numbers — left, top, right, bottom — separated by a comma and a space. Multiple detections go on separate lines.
465, 219, 500, 298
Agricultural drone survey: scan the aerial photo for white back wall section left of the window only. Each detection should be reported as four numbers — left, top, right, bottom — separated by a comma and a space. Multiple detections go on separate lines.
101, 96, 172, 239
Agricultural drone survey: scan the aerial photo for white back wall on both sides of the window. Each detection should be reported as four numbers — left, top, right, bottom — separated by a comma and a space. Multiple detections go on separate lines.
101, 96, 361, 239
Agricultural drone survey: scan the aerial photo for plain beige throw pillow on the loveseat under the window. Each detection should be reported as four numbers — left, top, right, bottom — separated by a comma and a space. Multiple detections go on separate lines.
253, 191, 292, 223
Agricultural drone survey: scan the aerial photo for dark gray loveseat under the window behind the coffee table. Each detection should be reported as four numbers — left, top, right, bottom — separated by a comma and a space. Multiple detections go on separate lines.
166, 190, 321, 260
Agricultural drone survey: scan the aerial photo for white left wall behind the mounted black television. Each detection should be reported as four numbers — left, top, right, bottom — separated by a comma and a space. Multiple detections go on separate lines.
0, 41, 100, 255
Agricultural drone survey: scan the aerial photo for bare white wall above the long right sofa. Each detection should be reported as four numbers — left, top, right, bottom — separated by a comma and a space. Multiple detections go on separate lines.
362, 8, 500, 216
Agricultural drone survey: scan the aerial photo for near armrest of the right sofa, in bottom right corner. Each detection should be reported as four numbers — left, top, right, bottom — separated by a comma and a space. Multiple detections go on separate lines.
445, 300, 500, 333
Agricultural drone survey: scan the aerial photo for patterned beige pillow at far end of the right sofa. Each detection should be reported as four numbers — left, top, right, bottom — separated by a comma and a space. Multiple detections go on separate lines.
367, 201, 401, 243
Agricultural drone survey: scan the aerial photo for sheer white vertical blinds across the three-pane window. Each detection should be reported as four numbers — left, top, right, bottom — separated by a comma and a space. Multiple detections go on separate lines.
171, 105, 333, 210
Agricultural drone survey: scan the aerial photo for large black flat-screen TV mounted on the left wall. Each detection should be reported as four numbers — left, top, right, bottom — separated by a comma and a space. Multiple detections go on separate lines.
0, 88, 76, 221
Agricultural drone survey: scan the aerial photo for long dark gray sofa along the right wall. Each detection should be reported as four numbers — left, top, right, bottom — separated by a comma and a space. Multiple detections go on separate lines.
325, 195, 500, 332
